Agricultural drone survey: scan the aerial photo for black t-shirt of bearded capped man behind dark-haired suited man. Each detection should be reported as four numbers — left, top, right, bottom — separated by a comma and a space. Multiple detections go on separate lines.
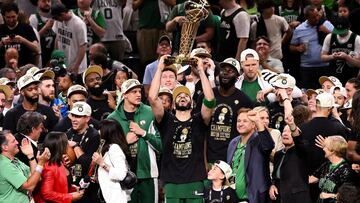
3, 103, 58, 143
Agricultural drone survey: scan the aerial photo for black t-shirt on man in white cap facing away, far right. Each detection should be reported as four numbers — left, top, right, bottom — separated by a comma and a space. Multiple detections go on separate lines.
300, 117, 350, 175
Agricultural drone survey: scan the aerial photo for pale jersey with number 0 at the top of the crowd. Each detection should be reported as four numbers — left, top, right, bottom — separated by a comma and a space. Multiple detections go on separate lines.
93, 0, 124, 42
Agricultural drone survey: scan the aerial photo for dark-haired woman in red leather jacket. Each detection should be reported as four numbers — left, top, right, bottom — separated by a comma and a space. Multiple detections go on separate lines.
34, 132, 84, 203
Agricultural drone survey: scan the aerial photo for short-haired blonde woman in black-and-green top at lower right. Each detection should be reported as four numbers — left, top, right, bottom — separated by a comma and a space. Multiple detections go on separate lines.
309, 136, 352, 203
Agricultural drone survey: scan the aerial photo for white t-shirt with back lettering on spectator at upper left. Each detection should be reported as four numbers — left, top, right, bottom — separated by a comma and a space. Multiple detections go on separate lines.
53, 12, 87, 74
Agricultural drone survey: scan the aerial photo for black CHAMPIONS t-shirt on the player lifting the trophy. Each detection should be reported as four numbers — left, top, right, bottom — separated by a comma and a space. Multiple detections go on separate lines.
156, 111, 207, 184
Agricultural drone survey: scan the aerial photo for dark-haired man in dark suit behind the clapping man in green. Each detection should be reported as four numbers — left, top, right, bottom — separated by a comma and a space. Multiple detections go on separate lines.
15, 111, 46, 165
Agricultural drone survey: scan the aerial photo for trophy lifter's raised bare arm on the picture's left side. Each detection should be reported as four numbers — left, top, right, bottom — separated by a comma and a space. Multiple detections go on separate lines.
148, 55, 167, 123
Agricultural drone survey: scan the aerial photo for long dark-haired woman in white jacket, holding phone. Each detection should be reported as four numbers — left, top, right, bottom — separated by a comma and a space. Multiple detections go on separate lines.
92, 120, 130, 203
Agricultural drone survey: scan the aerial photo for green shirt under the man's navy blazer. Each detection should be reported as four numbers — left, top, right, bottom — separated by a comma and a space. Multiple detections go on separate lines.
232, 142, 247, 199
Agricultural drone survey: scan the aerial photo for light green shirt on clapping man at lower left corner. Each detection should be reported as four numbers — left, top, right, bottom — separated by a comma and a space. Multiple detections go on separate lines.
0, 154, 30, 203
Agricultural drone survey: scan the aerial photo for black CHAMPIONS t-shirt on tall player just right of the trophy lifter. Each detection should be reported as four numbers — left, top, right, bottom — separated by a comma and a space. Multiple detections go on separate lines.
196, 88, 254, 163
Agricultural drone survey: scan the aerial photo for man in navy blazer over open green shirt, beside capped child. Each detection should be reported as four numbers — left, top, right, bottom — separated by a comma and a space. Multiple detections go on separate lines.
227, 108, 274, 203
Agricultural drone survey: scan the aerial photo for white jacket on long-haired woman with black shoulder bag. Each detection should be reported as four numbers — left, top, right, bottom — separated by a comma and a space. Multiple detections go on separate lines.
98, 144, 131, 203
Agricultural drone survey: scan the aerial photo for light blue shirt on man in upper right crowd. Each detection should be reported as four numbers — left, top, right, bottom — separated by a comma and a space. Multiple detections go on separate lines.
291, 21, 334, 67
